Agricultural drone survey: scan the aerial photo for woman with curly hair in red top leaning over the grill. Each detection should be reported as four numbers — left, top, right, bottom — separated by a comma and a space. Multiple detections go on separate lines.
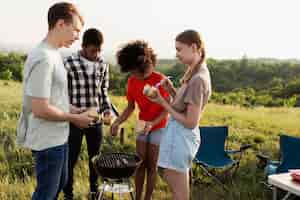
111, 41, 169, 200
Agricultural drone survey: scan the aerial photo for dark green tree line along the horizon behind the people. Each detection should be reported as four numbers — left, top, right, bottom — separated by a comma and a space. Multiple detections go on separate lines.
0, 52, 300, 107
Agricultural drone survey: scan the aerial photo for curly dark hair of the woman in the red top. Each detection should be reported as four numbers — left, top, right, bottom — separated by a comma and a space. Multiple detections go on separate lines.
116, 40, 156, 73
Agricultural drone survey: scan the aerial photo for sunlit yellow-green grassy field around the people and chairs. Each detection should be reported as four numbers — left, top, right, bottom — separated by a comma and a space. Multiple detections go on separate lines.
0, 81, 300, 200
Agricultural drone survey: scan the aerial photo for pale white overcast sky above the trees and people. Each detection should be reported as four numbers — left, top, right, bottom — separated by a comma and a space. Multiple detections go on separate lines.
0, 0, 300, 59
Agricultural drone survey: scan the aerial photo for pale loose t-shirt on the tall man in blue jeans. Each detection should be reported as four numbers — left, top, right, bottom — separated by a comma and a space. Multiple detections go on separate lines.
21, 42, 69, 151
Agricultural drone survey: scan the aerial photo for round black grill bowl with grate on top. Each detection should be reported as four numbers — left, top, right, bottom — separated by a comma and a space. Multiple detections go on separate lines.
92, 153, 142, 180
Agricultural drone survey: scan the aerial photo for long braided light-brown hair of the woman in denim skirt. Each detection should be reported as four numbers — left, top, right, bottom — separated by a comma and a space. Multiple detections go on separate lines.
175, 30, 206, 84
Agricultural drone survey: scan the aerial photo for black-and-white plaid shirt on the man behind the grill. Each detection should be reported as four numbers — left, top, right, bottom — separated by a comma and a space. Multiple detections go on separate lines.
64, 52, 111, 112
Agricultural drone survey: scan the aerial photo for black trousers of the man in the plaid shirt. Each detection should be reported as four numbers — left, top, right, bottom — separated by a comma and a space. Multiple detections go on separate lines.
63, 124, 102, 199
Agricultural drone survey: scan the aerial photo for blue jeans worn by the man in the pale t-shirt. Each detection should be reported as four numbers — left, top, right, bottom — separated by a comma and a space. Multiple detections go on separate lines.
32, 144, 68, 200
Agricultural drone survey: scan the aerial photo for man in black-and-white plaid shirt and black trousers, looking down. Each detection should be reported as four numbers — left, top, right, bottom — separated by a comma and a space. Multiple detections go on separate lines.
64, 28, 112, 199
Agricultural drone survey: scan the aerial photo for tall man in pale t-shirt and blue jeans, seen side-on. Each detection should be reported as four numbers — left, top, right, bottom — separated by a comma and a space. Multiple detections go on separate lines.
17, 2, 93, 200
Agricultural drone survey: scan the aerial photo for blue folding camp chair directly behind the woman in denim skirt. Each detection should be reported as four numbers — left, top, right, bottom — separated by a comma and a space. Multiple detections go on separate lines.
194, 126, 251, 189
